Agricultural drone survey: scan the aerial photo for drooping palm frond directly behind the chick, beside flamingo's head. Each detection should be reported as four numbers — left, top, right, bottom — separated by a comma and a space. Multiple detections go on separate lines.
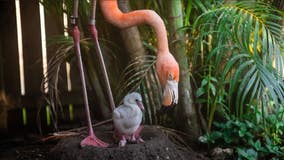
115, 55, 161, 124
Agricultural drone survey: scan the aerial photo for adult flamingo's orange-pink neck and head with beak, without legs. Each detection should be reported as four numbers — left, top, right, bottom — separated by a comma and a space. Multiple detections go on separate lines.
100, 0, 179, 106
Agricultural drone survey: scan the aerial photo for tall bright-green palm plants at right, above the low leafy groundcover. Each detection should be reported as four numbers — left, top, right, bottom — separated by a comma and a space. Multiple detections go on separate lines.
188, 0, 284, 130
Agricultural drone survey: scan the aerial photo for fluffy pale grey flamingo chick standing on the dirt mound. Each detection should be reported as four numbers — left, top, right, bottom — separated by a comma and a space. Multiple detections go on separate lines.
112, 92, 144, 147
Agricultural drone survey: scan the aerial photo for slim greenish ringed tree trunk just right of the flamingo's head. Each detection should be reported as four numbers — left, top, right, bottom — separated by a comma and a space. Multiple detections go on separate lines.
165, 0, 200, 137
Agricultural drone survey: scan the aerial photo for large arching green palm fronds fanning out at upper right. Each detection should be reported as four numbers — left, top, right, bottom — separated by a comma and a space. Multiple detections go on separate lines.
193, 1, 284, 115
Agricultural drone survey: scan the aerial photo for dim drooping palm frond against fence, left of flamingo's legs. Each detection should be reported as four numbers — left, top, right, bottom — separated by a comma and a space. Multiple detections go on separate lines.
41, 35, 102, 128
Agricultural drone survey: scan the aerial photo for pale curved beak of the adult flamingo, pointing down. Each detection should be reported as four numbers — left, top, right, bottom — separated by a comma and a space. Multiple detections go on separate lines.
162, 79, 178, 107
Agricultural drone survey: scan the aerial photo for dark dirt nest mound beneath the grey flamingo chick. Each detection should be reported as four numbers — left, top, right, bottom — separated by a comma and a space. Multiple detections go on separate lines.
49, 126, 208, 160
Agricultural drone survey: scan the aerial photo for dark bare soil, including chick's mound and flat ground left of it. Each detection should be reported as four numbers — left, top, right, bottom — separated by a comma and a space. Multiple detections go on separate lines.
0, 125, 212, 160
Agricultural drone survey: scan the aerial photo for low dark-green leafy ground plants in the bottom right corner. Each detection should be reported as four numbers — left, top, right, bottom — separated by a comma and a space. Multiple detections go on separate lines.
199, 106, 284, 160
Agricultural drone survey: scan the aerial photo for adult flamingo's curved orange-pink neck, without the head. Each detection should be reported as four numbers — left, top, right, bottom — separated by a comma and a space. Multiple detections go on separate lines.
100, 0, 169, 54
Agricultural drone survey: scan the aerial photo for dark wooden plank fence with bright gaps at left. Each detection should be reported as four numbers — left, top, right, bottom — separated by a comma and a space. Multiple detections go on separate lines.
0, 0, 87, 131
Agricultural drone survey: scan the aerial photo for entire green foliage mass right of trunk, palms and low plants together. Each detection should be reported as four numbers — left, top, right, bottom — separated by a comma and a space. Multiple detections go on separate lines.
189, 1, 284, 159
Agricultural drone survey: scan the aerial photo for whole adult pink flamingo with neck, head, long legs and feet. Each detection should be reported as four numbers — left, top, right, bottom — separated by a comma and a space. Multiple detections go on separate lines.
71, 0, 179, 147
